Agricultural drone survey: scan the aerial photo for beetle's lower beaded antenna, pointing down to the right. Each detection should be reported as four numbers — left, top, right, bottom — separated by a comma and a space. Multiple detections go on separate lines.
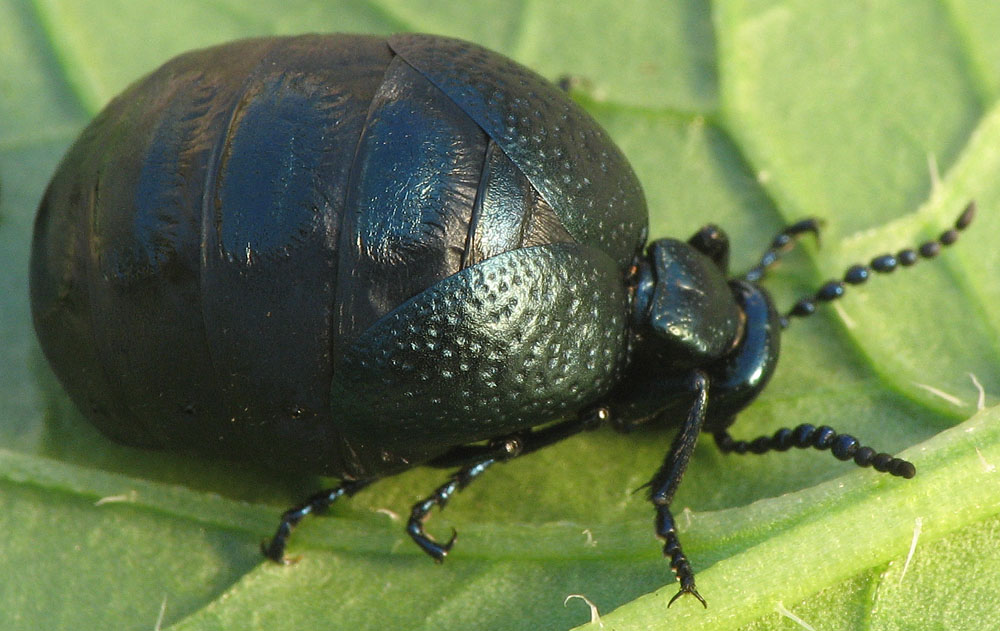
714, 423, 917, 479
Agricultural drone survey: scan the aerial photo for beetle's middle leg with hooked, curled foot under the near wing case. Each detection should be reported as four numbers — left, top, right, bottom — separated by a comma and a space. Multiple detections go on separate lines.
406, 407, 610, 563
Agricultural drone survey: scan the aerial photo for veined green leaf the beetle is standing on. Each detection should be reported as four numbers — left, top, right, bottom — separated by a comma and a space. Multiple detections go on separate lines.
0, 0, 1000, 631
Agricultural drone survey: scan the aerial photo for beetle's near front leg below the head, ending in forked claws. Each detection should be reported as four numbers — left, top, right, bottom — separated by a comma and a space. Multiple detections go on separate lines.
649, 371, 708, 607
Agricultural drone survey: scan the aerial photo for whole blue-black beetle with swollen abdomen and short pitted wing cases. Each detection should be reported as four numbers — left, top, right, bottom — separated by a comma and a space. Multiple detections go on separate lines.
31, 34, 974, 604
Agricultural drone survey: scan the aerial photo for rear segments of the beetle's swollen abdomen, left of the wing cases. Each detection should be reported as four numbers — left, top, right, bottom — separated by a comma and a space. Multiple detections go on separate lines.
32, 37, 392, 460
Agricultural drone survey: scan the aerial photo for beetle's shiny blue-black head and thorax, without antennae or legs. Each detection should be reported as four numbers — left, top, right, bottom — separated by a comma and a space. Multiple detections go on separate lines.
615, 238, 781, 429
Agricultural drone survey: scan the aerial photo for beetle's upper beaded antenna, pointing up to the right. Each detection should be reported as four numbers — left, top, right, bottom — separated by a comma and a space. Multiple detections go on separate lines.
780, 201, 976, 329
